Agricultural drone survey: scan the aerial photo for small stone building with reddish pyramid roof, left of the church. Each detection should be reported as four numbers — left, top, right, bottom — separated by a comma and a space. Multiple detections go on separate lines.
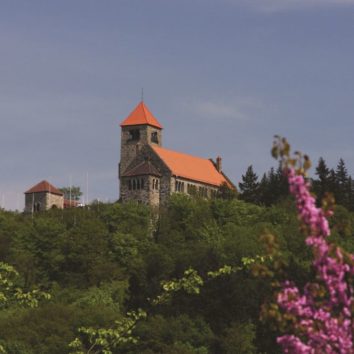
25, 181, 64, 213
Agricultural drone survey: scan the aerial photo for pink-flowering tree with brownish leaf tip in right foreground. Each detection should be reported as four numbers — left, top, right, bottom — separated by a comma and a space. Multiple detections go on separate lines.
268, 138, 354, 353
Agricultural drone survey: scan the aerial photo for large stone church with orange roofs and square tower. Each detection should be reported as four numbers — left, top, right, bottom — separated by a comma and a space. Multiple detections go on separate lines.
119, 101, 236, 206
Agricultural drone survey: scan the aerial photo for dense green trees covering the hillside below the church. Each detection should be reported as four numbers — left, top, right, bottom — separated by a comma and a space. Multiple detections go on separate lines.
0, 195, 354, 354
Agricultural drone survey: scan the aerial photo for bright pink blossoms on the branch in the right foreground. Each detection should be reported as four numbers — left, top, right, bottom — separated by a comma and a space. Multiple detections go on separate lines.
277, 168, 354, 354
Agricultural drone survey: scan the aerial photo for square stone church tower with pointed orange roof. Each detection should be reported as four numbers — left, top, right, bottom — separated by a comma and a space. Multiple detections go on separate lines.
119, 101, 162, 177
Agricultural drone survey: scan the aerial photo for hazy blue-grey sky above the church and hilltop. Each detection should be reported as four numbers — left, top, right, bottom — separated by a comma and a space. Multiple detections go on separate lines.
0, 0, 354, 208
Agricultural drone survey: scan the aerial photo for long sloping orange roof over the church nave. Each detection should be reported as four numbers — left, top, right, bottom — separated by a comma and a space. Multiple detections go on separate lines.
151, 146, 230, 186
